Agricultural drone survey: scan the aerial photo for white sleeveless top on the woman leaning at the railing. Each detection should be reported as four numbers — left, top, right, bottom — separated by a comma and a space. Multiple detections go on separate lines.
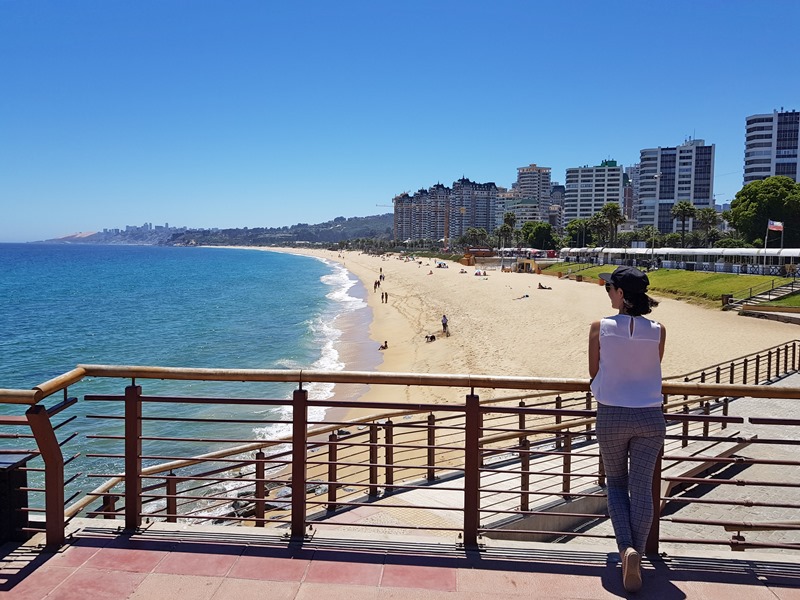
591, 315, 663, 408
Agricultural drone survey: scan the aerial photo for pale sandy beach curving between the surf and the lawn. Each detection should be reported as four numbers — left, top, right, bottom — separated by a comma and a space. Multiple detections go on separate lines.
252, 248, 797, 412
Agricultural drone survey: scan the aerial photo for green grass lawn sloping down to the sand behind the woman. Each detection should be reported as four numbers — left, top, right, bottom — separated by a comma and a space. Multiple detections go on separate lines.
544, 263, 784, 306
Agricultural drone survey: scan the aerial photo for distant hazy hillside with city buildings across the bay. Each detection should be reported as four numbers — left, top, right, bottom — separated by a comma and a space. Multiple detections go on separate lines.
47, 213, 394, 246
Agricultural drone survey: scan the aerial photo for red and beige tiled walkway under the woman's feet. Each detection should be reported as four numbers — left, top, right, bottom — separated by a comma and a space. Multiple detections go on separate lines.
0, 520, 800, 600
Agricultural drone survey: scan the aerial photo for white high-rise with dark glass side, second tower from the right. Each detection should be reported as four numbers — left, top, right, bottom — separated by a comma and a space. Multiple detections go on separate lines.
637, 139, 715, 233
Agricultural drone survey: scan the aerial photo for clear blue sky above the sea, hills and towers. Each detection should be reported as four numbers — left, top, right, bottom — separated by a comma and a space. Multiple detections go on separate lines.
0, 0, 800, 242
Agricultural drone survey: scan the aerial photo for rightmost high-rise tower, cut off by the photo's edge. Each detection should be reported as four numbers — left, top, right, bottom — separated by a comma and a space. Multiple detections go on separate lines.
744, 108, 800, 185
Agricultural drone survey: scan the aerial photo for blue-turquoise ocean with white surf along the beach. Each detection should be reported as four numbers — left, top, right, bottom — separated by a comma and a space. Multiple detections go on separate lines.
0, 244, 377, 470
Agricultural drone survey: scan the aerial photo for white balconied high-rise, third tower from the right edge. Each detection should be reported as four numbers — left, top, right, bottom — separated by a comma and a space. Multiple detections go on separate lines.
564, 160, 623, 223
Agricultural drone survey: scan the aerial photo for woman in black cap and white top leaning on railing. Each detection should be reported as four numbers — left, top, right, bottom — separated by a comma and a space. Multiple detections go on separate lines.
589, 266, 667, 592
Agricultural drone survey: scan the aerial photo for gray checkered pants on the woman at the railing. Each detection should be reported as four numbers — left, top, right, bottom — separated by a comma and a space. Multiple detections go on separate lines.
597, 403, 666, 553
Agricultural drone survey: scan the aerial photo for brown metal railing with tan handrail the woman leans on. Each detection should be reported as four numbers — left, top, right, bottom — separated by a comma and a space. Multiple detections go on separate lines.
0, 342, 800, 551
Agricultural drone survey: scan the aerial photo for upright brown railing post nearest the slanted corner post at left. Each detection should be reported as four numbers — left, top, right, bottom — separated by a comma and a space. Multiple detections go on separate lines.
125, 385, 142, 531
